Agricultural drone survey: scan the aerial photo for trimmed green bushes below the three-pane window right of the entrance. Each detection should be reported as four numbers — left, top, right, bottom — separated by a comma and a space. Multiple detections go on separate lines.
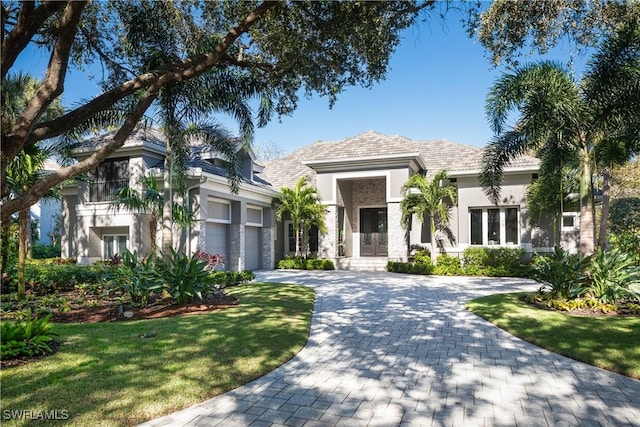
387, 248, 529, 277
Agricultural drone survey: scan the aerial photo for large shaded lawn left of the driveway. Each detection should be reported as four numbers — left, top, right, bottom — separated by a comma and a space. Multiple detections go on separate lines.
0, 283, 314, 426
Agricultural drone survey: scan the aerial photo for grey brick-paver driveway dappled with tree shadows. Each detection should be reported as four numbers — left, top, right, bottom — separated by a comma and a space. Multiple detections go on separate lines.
145, 271, 640, 427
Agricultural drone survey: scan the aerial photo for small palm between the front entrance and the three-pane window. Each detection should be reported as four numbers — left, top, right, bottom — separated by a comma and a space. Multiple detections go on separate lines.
400, 170, 458, 264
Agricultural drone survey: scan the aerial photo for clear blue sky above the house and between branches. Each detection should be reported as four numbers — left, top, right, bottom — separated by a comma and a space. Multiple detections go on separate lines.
14, 13, 584, 153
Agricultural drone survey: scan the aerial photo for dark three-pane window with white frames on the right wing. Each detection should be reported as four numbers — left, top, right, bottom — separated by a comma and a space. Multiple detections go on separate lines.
469, 208, 520, 245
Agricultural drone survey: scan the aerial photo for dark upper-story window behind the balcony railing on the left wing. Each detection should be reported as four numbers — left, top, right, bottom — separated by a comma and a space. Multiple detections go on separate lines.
89, 158, 129, 202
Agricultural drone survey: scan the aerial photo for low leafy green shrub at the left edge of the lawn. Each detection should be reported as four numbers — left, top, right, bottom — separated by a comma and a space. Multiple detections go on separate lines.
0, 313, 57, 359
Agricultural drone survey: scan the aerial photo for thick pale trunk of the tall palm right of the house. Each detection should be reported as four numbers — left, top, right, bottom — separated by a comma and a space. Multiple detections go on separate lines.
580, 144, 595, 257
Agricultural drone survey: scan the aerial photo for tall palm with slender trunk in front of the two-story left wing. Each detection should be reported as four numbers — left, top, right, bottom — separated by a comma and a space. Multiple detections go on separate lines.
116, 2, 272, 254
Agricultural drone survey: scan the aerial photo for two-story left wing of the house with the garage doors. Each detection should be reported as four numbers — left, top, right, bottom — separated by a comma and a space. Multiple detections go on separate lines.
62, 129, 278, 270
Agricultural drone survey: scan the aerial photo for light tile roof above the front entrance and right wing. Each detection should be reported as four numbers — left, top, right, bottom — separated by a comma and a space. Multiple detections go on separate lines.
261, 131, 538, 189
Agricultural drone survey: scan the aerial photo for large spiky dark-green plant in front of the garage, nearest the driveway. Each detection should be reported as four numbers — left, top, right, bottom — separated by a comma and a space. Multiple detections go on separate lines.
155, 248, 213, 304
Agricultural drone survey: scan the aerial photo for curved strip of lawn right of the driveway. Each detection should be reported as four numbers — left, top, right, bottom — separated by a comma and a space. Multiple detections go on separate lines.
466, 293, 640, 379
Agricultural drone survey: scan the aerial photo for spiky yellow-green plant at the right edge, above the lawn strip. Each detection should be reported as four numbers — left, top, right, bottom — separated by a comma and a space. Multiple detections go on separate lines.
587, 249, 640, 303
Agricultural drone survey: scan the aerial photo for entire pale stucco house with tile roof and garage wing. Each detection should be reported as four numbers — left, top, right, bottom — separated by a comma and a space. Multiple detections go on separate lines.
63, 130, 568, 270
